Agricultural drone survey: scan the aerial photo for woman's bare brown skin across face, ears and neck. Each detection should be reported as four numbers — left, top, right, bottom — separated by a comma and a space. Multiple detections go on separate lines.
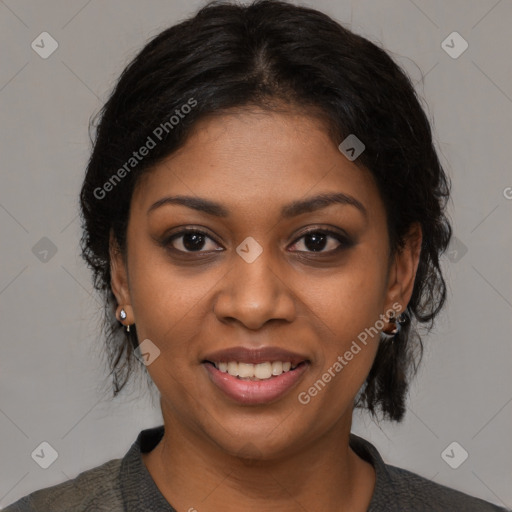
111, 108, 421, 512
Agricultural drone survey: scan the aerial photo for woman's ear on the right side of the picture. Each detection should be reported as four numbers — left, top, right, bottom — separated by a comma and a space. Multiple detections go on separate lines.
387, 222, 423, 312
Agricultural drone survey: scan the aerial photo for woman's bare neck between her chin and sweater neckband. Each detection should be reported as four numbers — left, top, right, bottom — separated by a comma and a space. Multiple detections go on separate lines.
143, 413, 375, 512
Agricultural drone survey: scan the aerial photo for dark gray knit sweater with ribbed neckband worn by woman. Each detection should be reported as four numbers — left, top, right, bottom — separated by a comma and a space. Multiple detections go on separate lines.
3, 426, 506, 512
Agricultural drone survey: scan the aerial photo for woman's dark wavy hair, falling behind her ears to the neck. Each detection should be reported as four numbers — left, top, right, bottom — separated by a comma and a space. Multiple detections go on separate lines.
80, 0, 451, 421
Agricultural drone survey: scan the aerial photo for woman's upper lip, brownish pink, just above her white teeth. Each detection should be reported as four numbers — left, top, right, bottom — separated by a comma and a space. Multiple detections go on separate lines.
203, 347, 308, 366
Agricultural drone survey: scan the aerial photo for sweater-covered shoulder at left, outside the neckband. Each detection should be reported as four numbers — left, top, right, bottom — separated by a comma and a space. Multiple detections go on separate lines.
2, 459, 123, 512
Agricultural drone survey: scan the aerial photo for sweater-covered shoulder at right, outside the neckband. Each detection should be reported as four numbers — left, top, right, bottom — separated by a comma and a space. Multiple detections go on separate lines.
386, 465, 506, 512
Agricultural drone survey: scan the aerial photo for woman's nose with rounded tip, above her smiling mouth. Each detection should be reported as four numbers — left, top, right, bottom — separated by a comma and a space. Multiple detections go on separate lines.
214, 245, 296, 330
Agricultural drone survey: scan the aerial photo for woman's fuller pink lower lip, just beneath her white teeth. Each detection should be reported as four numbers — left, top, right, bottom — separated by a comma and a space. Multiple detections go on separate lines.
203, 362, 308, 405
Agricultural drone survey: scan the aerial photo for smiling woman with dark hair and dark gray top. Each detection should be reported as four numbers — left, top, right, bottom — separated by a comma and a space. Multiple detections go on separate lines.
6, 0, 503, 512
